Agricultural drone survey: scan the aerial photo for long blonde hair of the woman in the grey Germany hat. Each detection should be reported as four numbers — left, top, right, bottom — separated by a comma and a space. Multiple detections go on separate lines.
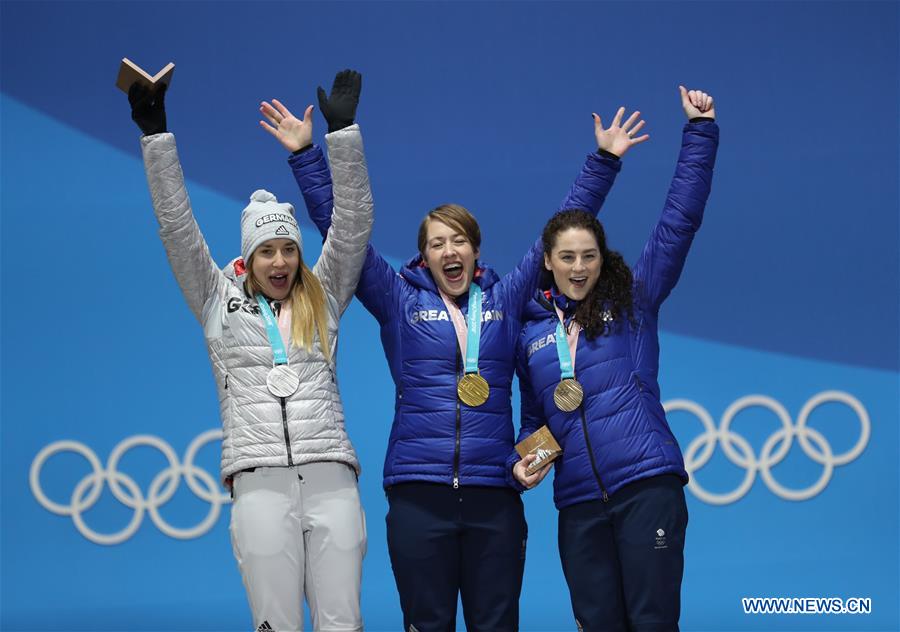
246, 255, 331, 362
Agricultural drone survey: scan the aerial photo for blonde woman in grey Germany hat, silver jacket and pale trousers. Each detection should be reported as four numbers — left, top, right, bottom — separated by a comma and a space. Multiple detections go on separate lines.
128, 75, 372, 631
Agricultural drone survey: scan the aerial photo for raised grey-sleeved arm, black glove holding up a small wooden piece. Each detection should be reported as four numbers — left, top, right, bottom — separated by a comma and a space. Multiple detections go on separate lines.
128, 83, 224, 324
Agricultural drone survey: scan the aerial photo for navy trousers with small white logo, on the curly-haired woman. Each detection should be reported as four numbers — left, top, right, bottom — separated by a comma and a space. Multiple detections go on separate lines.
559, 475, 688, 632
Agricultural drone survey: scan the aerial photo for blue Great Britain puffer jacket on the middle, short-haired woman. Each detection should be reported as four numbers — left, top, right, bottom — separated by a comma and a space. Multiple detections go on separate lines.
289, 147, 620, 487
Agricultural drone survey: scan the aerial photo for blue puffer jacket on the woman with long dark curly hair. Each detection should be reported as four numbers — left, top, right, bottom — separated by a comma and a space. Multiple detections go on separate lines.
507, 121, 719, 509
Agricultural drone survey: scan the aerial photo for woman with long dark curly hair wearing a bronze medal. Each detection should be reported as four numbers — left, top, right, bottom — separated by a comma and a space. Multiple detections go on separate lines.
507, 87, 719, 631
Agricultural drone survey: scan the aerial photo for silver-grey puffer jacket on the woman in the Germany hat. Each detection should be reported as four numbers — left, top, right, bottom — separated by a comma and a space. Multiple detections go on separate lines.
141, 125, 372, 484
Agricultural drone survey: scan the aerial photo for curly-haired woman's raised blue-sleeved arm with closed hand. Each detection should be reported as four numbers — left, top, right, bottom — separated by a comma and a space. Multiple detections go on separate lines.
633, 86, 719, 309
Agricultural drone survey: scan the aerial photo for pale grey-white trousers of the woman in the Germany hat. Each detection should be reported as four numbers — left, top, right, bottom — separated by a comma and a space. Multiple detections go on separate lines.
231, 462, 366, 632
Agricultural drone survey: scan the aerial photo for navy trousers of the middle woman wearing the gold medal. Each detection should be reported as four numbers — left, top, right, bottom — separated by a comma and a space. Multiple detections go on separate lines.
387, 483, 528, 632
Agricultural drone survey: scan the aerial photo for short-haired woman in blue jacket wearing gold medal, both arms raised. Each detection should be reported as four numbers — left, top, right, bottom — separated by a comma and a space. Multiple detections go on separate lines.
262, 70, 647, 632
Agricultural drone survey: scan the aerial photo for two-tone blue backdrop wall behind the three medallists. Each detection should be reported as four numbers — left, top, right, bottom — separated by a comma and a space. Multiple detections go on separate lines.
0, 1, 900, 631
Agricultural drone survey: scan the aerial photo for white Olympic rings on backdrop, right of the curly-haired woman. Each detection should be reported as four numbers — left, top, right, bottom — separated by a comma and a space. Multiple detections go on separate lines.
663, 391, 871, 505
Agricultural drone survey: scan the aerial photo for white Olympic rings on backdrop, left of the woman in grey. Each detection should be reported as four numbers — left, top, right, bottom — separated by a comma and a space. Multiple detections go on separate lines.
29, 429, 231, 545
